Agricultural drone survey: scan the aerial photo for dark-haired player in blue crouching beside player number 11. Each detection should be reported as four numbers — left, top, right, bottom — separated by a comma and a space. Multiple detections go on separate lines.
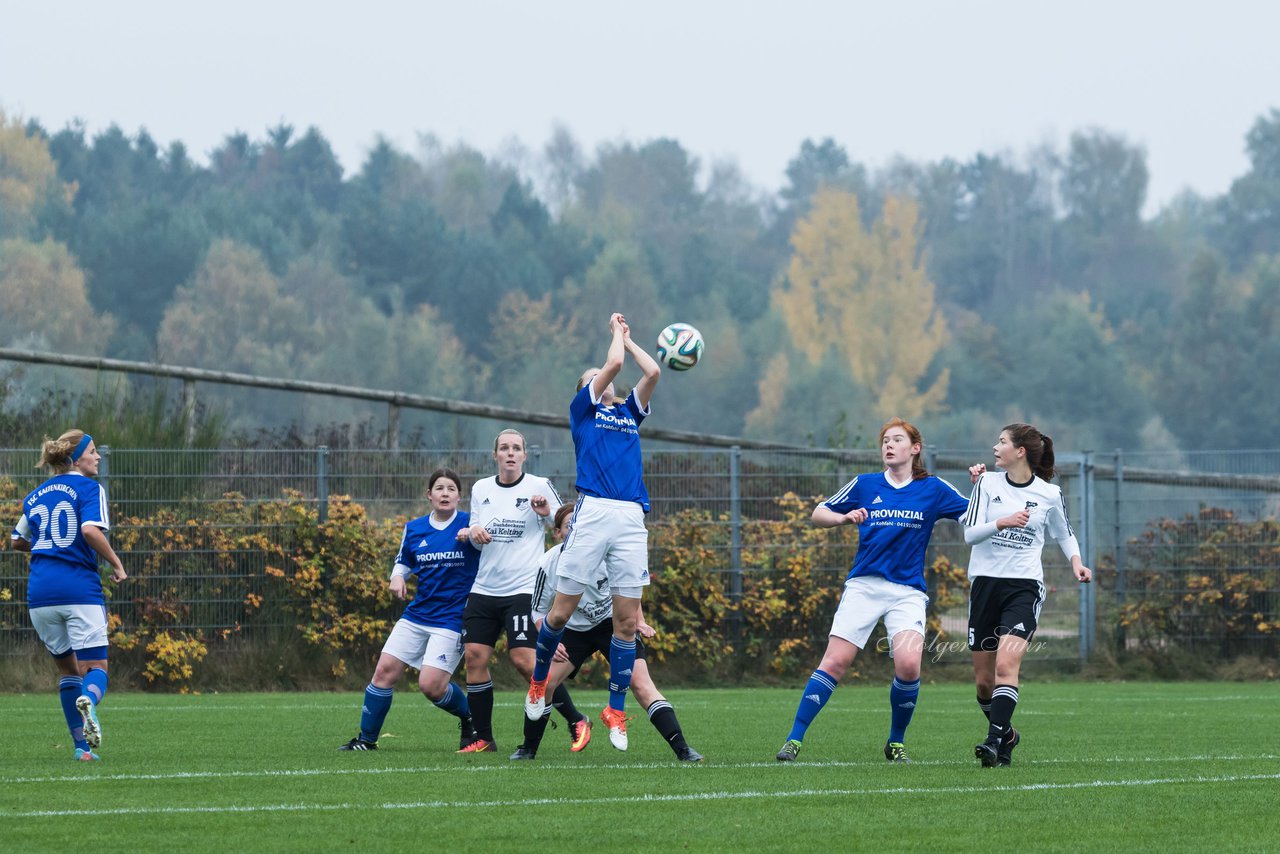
339, 469, 480, 750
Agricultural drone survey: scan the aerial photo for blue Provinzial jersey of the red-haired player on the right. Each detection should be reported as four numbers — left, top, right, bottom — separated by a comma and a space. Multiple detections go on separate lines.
822, 471, 969, 590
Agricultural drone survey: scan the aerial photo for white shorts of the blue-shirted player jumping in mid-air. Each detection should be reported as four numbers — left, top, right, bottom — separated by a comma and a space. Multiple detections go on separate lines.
556, 495, 649, 590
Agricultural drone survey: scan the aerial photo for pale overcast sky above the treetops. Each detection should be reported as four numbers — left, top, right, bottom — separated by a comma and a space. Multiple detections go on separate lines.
0, 0, 1280, 213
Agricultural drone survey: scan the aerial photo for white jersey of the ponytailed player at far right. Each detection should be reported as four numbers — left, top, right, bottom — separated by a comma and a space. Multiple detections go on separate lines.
963, 471, 1080, 581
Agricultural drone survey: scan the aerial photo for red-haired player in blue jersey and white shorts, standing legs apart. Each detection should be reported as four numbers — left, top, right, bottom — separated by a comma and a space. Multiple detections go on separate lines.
777, 419, 969, 762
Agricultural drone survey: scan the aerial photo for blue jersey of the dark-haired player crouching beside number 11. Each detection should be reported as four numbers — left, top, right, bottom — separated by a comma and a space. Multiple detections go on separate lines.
396, 512, 480, 632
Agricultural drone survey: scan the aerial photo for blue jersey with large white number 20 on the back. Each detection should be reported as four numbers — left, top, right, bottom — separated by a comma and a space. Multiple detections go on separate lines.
13, 472, 111, 608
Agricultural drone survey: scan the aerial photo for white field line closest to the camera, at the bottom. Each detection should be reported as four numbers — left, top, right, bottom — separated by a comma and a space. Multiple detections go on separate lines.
10, 773, 1280, 818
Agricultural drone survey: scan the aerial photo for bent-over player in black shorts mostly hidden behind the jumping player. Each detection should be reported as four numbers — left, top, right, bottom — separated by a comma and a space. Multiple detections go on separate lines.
511, 507, 703, 762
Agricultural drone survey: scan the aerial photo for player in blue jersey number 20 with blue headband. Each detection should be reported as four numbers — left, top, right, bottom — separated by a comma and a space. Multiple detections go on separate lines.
12, 430, 128, 762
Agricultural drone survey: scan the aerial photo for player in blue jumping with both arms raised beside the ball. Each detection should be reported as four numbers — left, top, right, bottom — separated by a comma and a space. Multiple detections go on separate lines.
525, 314, 662, 750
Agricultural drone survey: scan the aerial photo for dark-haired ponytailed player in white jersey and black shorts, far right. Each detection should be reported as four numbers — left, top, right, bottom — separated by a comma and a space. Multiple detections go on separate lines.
964, 424, 1093, 768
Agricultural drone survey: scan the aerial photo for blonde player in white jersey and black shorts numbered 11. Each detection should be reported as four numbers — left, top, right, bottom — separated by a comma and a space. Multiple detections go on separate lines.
460, 429, 591, 753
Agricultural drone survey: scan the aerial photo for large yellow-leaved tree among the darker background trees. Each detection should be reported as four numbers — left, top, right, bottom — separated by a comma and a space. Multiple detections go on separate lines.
773, 188, 950, 419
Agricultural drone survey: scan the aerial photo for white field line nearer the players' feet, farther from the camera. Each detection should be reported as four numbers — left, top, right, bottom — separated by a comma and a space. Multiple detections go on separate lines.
0, 753, 1280, 786
